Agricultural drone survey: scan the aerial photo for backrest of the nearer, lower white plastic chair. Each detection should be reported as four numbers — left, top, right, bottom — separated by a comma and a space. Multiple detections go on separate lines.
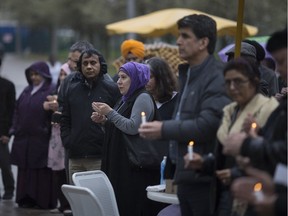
61, 184, 105, 216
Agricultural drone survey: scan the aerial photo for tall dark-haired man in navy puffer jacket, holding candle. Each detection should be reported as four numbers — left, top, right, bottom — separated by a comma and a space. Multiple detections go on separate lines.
139, 14, 230, 216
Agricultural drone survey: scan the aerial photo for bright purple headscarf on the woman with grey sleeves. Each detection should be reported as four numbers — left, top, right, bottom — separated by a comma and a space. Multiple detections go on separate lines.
119, 62, 150, 102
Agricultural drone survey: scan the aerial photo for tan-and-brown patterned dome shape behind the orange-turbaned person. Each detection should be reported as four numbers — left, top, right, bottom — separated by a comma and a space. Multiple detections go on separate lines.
113, 42, 185, 75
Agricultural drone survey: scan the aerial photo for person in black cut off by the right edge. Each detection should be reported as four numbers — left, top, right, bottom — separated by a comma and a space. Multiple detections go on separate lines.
224, 28, 287, 215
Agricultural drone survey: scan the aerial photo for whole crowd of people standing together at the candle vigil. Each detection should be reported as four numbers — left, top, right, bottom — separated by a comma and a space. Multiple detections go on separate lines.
0, 14, 287, 216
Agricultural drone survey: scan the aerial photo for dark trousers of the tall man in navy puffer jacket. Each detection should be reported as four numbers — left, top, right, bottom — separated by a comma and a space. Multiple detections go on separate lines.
177, 183, 212, 216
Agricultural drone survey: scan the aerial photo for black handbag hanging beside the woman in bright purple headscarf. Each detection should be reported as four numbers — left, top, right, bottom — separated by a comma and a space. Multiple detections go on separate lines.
123, 133, 168, 169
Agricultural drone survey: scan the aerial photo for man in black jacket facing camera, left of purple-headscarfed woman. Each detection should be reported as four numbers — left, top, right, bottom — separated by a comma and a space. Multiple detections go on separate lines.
61, 49, 120, 183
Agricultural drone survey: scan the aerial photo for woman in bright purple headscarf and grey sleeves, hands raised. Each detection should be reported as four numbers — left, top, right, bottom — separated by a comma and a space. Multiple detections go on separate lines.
91, 62, 160, 216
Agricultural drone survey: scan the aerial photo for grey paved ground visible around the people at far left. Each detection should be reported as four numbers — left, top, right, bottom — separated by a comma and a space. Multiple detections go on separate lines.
0, 54, 61, 216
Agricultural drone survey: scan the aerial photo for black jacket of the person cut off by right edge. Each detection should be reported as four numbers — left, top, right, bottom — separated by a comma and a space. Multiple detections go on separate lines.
241, 97, 287, 176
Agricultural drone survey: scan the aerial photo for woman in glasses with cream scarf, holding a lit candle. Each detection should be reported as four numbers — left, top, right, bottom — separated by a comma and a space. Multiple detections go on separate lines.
185, 58, 278, 216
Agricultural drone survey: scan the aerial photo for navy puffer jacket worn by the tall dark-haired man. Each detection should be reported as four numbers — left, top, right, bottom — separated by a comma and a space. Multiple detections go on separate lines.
162, 55, 230, 184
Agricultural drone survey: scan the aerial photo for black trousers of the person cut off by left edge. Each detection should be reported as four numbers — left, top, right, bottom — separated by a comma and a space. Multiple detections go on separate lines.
0, 141, 15, 195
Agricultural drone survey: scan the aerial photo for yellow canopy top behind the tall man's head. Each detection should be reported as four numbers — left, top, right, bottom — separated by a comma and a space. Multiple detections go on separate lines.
106, 8, 258, 37
